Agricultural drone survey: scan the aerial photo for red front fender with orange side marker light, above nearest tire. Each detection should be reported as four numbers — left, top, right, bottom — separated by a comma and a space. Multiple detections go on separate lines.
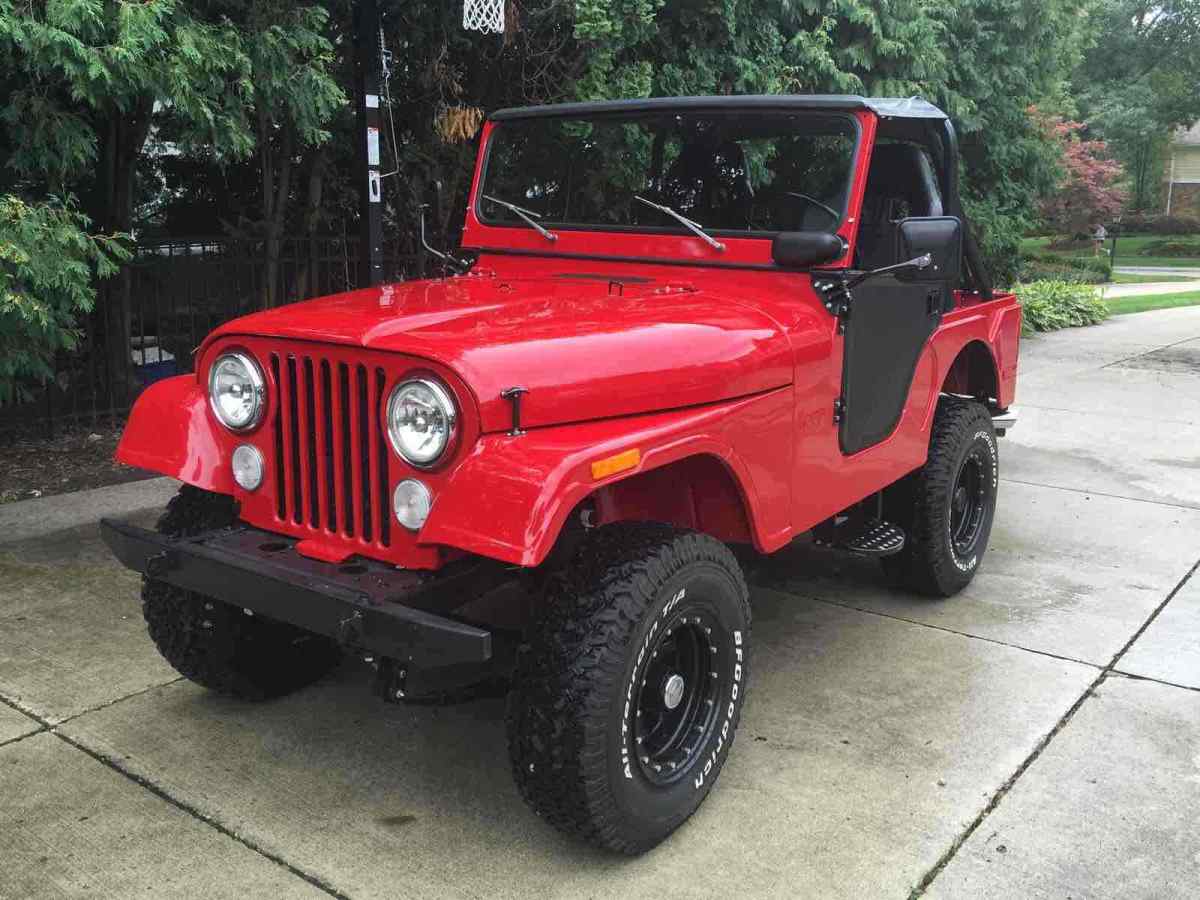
420, 385, 792, 566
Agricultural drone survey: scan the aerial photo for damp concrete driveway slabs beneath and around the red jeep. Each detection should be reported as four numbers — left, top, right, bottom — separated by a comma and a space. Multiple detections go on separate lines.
0, 307, 1200, 899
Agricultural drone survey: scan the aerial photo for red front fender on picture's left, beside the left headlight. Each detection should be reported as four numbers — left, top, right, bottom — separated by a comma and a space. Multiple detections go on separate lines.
116, 374, 233, 493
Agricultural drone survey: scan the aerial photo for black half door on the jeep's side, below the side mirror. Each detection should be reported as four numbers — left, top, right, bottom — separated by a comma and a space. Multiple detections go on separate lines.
840, 275, 942, 454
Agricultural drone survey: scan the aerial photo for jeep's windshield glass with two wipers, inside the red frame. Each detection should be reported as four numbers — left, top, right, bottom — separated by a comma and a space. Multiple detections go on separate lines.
479, 112, 857, 235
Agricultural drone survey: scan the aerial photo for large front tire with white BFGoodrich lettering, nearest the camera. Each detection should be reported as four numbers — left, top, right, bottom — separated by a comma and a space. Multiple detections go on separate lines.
508, 523, 750, 854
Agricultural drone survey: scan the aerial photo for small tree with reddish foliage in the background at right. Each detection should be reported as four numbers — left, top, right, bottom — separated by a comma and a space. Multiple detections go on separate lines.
1031, 110, 1126, 235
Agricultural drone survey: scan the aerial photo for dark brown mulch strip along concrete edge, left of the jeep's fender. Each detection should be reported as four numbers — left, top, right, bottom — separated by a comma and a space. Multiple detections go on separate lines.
0, 420, 154, 503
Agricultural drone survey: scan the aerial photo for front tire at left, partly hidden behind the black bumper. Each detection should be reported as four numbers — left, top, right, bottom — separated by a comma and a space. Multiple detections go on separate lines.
142, 485, 340, 700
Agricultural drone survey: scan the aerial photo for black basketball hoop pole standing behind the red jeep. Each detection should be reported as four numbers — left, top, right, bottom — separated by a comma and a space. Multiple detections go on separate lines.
354, 0, 383, 288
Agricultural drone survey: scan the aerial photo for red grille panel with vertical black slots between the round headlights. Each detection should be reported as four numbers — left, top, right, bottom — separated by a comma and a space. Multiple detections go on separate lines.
270, 353, 391, 546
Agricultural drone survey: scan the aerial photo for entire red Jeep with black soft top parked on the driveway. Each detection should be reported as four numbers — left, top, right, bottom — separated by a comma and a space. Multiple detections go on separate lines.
103, 96, 1021, 853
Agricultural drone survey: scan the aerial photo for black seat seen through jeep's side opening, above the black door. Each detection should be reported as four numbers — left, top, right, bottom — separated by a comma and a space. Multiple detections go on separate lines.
854, 144, 942, 269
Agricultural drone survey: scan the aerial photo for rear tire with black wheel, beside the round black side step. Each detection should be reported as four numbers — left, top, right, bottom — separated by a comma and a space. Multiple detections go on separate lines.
882, 397, 1000, 596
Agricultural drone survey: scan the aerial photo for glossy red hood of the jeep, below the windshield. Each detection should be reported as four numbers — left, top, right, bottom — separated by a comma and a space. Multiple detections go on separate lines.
205, 274, 792, 432
